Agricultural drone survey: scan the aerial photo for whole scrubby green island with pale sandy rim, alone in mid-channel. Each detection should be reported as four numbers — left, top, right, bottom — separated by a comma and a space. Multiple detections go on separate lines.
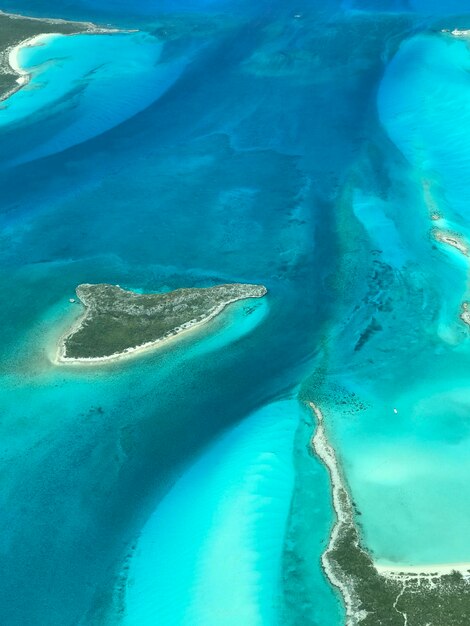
57, 283, 267, 363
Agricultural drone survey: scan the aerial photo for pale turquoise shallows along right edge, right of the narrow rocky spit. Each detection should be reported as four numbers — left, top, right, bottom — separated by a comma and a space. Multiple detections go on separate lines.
320, 26, 470, 566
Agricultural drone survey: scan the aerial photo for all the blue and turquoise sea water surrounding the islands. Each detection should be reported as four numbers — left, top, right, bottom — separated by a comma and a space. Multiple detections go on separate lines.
0, 0, 470, 626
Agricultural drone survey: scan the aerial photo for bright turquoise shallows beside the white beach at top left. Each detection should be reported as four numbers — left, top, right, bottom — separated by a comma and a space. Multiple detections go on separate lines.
0, 33, 185, 163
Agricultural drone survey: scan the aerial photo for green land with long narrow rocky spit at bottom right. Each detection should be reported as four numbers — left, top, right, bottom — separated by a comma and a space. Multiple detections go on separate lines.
307, 402, 470, 626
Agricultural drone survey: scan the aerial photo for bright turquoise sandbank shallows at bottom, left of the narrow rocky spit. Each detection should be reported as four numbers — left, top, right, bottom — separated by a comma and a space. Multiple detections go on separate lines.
124, 400, 299, 625
